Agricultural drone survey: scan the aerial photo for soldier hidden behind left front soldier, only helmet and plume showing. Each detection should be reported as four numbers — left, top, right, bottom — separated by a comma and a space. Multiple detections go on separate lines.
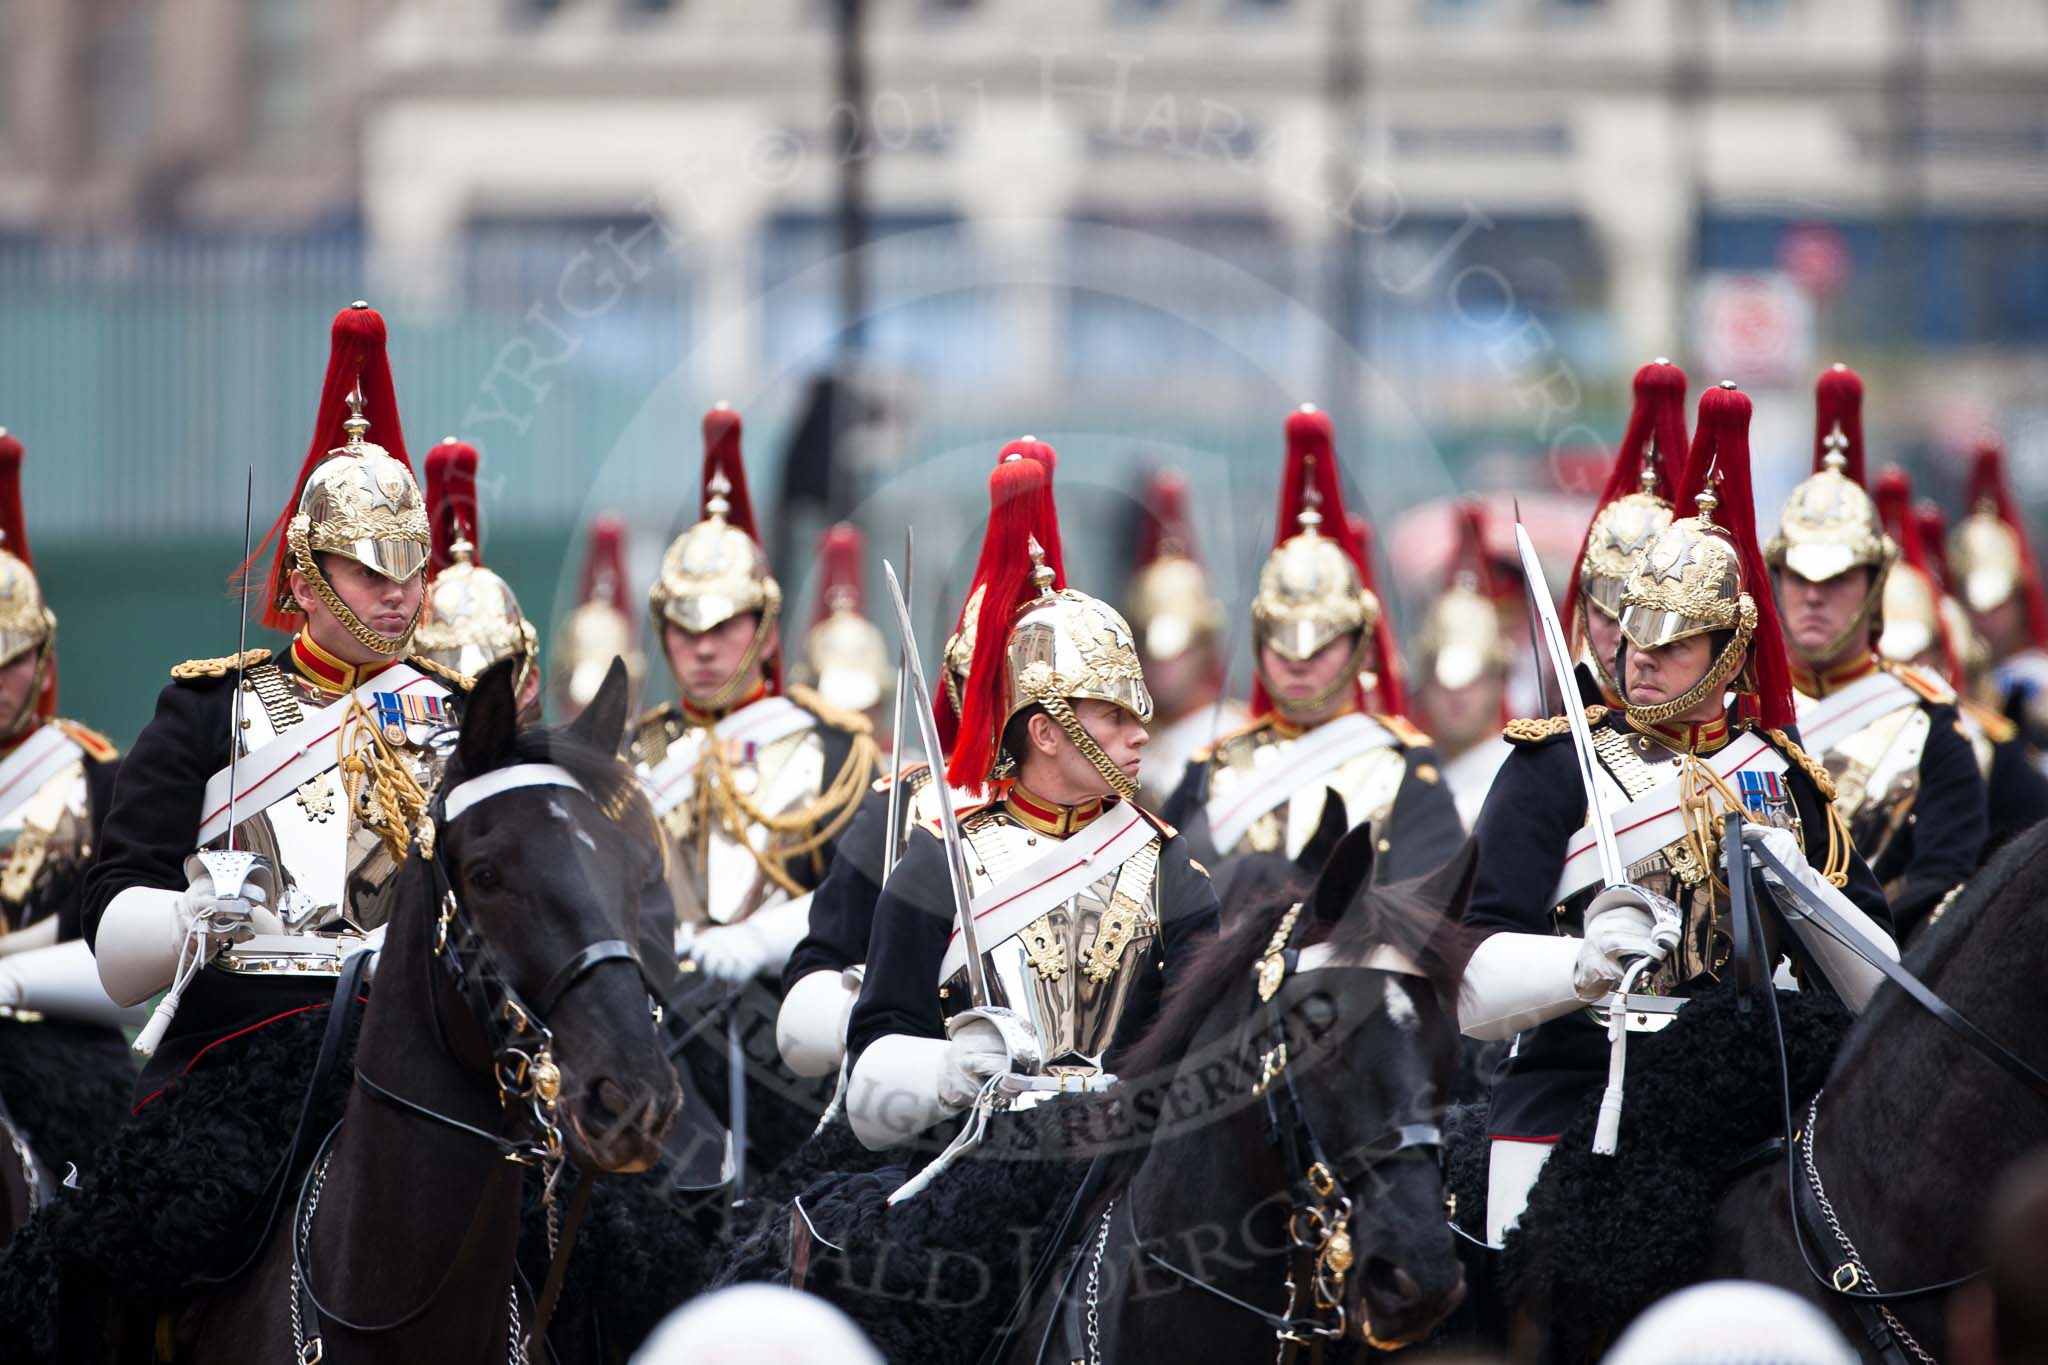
412, 436, 540, 724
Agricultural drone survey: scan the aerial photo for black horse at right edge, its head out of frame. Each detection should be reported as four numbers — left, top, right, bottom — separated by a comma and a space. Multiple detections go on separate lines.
1708, 825, 2048, 1359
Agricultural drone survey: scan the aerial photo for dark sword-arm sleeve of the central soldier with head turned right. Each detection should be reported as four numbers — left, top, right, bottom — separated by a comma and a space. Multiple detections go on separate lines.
846, 825, 954, 1062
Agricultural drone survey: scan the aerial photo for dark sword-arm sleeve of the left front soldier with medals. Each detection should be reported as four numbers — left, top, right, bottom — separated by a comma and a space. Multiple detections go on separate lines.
80, 677, 233, 941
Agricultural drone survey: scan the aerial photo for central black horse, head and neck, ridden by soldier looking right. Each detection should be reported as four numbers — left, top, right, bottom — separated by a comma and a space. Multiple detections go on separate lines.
1006, 829, 1475, 1365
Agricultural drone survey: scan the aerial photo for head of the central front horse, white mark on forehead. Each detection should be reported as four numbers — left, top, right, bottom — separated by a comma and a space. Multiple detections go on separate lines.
1257, 827, 1475, 1347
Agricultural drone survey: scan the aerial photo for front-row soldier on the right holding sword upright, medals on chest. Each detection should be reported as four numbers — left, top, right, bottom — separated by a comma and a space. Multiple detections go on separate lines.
1460, 385, 1894, 1242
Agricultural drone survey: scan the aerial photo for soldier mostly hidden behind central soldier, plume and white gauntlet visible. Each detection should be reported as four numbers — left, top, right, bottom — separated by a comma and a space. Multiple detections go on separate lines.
776, 448, 1067, 1076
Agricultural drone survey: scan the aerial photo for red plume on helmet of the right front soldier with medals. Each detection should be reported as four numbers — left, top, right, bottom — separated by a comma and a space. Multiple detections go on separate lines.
1673, 383, 1794, 729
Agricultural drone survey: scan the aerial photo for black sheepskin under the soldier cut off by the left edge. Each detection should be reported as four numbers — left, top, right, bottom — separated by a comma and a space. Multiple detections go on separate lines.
0, 1019, 135, 1181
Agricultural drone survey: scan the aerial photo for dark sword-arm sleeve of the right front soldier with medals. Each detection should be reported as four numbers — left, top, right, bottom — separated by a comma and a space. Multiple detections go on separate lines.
1464, 737, 1585, 935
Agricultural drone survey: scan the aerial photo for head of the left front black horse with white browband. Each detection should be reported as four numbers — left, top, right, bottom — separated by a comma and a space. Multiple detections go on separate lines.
434, 659, 682, 1171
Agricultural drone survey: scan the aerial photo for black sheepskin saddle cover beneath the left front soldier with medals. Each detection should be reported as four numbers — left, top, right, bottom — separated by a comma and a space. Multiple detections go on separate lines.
0, 1007, 354, 1361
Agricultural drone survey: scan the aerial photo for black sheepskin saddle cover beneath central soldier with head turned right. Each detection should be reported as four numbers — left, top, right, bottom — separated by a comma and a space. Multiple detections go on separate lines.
719, 1105, 1090, 1365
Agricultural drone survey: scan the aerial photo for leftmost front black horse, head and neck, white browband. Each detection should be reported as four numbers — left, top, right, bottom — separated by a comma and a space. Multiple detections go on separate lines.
180, 663, 680, 1365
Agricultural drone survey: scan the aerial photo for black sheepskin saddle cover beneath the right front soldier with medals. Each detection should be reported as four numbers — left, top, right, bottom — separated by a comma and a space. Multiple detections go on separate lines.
1499, 986, 1851, 1361
